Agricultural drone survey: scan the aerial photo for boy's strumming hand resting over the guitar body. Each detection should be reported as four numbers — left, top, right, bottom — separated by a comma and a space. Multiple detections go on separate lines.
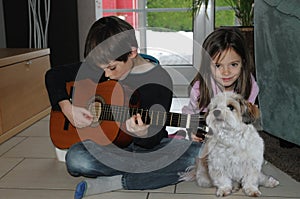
59, 100, 93, 128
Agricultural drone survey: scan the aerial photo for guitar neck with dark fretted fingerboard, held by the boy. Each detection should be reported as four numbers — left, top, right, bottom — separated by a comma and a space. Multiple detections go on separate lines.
99, 104, 205, 128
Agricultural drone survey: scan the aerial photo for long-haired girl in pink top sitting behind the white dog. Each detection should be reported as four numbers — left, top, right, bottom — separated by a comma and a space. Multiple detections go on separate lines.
182, 28, 259, 142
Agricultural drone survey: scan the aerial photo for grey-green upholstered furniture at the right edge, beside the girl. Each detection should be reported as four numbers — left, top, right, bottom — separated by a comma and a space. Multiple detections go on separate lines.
254, 0, 300, 145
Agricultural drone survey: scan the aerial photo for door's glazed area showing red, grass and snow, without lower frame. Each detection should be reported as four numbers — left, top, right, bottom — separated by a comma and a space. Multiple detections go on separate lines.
99, 0, 193, 66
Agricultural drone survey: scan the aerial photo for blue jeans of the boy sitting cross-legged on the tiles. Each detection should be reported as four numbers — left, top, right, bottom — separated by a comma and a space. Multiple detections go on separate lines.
66, 138, 201, 190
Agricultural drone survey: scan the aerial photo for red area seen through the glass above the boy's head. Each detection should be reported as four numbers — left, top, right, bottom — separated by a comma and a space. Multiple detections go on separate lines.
102, 0, 138, 28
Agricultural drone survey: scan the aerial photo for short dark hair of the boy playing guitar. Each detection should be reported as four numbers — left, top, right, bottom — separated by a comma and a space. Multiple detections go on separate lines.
84, 16, 138, 64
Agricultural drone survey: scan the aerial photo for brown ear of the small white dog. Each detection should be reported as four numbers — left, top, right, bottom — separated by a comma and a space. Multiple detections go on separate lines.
241, 99, 260, 124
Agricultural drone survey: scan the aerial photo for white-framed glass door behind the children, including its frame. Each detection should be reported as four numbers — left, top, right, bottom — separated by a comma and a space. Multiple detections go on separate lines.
96, 0, 214, 97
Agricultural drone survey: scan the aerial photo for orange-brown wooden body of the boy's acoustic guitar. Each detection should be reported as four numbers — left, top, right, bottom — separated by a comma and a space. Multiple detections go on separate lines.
50, 79, 132, 149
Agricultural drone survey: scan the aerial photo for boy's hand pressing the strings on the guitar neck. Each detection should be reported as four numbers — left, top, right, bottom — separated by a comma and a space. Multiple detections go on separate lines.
126, 113, 149, 137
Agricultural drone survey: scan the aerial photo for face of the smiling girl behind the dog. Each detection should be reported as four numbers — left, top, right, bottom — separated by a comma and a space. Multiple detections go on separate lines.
210, 48, 242, 91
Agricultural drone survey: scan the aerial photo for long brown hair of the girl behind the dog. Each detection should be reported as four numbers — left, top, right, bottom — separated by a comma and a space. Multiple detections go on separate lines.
191, 28, 253, 110
